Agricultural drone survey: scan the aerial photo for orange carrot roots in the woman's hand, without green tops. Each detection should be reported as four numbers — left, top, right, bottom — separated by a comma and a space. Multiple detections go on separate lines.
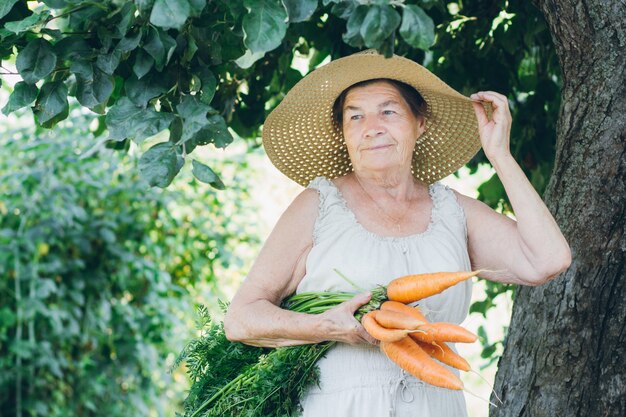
361, 271, 480, 390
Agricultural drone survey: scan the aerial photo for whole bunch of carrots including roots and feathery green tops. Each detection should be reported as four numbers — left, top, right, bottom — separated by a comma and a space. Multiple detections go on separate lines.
179, 271, 480, 417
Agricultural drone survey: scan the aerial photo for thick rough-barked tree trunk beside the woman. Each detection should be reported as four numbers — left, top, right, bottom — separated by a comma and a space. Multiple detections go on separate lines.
490, 0, 626, 417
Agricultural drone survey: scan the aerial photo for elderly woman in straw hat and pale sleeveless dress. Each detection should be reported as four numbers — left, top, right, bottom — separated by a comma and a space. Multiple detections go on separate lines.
225, 51, 570, 417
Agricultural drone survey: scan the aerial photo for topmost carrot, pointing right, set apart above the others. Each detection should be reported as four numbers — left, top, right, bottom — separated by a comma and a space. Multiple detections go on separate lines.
387, 270, 481, 304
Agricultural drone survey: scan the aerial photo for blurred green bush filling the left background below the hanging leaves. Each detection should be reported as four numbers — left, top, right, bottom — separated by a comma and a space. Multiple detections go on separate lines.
0, 111, 258, 417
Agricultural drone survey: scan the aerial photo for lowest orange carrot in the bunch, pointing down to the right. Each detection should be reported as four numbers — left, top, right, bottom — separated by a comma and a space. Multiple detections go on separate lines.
380, 337, 463, 390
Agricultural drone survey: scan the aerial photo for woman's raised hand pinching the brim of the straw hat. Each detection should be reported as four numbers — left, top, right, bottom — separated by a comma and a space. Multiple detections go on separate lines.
470, 91, 512, 164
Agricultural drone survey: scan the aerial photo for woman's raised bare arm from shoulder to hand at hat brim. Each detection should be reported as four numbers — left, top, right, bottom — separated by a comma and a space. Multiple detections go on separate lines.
459, 91, 571, 285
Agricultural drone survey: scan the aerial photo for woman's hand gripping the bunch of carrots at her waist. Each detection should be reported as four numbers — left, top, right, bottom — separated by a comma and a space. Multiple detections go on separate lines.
320, 292, 378, 345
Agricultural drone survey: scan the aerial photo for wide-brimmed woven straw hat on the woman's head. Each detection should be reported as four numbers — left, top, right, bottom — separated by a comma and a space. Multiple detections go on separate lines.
263, 50, 491, 186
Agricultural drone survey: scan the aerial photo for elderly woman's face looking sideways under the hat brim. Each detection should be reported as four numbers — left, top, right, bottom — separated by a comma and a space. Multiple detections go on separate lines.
343, 81, 425, 173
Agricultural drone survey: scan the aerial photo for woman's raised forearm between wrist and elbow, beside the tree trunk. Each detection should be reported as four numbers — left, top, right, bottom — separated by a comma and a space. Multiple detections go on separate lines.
492, 155, 571, 276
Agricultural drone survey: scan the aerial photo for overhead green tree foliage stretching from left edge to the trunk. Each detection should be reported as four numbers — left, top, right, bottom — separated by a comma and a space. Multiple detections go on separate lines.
0, 0, 560, 193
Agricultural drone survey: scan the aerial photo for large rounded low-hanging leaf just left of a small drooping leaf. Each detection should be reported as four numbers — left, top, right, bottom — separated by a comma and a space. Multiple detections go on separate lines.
139, 142, 182, 188
